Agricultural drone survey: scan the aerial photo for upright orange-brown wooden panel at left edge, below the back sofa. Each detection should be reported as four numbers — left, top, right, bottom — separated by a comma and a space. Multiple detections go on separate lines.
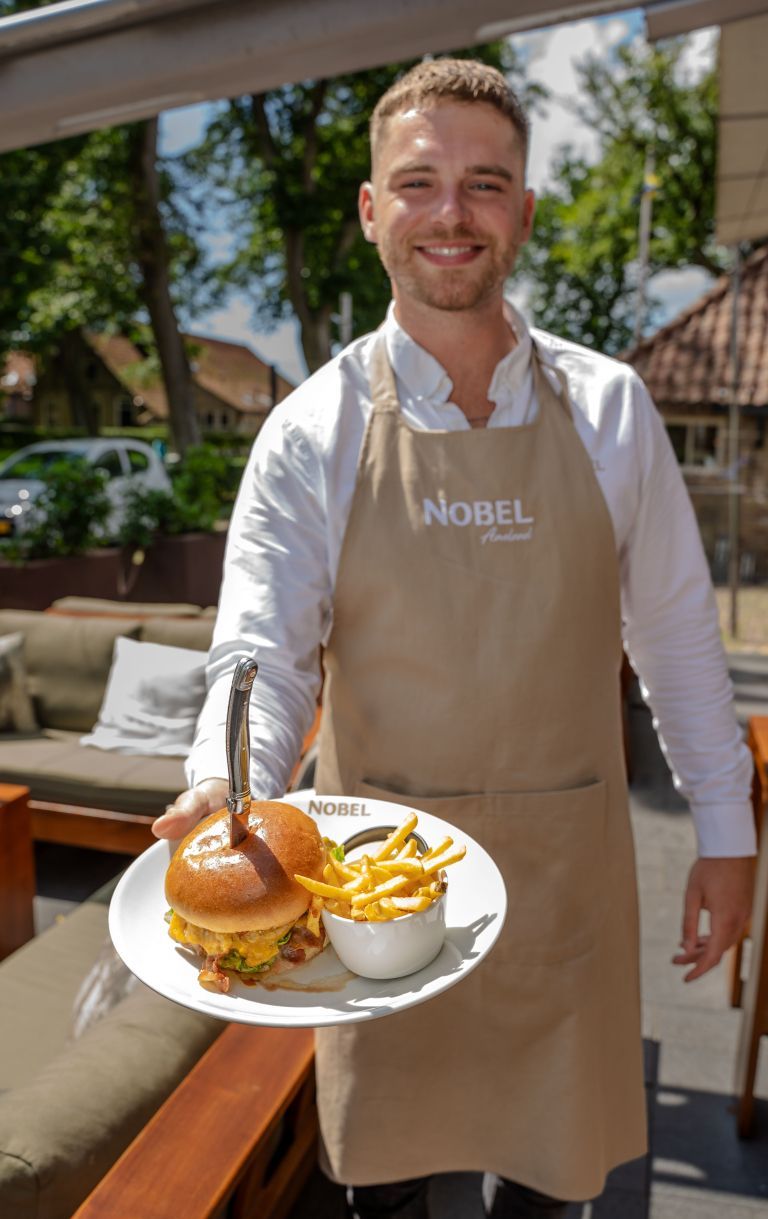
0, 783, 34, 961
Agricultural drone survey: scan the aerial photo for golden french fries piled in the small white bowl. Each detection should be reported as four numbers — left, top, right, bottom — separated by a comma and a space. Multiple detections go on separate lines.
295, 813, 467, 923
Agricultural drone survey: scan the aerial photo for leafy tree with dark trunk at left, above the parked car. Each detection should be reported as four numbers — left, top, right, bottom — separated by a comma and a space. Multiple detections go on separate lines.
0, 87, 211, 453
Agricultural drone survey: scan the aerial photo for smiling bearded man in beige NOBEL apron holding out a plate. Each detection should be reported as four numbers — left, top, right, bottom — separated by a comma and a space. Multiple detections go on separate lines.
156, 60, 755, 1219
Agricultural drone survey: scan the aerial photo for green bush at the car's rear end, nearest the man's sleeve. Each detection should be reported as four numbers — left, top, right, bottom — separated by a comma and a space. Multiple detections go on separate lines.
117, 445, 229, 550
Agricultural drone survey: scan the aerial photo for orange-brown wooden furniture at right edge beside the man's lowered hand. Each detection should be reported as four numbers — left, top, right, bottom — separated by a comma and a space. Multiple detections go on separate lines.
735, 716, 768, 1137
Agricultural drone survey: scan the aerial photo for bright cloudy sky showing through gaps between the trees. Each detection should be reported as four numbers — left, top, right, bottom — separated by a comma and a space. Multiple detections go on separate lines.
161, 9, 717, 382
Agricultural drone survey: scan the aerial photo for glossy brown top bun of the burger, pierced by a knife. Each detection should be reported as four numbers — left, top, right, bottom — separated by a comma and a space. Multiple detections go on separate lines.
166, 800, 325, 931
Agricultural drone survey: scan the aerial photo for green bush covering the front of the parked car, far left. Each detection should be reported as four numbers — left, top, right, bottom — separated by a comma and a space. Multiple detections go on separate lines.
4, 457, 111, 562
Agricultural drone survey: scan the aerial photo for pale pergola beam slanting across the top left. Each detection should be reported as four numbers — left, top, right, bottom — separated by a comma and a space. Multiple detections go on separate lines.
0, 0, 672, 151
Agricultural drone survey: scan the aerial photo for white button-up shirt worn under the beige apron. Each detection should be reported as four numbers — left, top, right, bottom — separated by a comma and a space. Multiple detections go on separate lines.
188, 298, 755, 856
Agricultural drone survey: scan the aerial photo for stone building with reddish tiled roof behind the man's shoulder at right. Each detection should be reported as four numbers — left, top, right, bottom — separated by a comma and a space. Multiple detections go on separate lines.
623, 246, 768, 579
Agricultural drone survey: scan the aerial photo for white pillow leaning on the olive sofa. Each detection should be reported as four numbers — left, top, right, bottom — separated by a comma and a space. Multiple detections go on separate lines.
80, 635, 207, 757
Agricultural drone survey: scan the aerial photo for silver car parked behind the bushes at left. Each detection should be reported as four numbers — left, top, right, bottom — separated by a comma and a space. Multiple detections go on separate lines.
0, 438, 171, 538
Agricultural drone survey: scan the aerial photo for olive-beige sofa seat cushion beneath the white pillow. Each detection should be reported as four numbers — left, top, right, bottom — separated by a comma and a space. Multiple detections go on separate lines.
0, 730, 187, 817
